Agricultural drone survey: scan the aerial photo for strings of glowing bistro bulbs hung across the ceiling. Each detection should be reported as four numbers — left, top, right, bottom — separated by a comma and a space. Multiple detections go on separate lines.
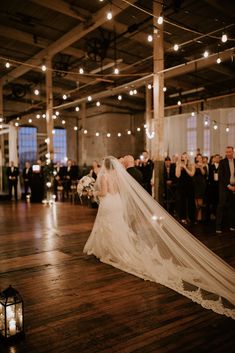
0, 0, 235, 139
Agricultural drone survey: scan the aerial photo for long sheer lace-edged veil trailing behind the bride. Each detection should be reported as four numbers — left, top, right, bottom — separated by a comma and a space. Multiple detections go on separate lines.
86, 157, 235, 319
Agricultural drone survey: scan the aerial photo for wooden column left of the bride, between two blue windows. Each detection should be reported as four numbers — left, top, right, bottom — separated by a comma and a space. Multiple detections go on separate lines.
46, 58, 54, 161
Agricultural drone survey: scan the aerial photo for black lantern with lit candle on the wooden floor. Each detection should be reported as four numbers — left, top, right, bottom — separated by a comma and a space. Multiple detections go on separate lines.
0, 286, 24, 340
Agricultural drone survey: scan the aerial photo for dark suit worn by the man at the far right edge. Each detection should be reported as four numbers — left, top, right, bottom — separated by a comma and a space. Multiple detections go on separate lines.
216, 158, 235, 230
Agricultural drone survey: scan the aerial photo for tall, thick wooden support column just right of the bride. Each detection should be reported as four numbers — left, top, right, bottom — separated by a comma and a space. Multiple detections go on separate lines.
152, 2, 164, 203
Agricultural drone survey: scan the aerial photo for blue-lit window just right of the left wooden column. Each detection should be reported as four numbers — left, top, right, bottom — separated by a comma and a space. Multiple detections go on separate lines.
53, 128, 67, 162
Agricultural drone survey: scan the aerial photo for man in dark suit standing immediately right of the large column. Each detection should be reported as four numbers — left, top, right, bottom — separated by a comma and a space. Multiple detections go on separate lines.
163, 156, 176, 214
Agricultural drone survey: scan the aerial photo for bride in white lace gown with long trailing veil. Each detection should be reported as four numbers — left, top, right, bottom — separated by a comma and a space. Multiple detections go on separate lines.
83, 157, 235, 319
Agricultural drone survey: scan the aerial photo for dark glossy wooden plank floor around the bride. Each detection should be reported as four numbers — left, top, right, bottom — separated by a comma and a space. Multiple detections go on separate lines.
0, 202, 235, 353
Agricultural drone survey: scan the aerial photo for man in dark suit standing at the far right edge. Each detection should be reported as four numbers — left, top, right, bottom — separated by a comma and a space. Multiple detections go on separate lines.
216, 146, 235, 233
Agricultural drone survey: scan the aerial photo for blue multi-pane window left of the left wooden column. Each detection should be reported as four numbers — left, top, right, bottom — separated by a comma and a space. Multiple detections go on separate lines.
18, 127, 37, 169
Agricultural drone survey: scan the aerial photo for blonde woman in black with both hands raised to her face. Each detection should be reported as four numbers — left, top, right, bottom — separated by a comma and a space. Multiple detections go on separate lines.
175, 152, 195, 224
